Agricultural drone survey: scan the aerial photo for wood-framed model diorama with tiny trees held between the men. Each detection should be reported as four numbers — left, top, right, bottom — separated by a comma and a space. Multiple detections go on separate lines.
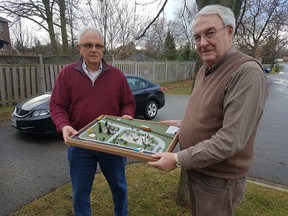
68, 116, 178, 160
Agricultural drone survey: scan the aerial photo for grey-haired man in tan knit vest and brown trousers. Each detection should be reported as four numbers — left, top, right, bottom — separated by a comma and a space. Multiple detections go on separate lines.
149, 5, 268, 216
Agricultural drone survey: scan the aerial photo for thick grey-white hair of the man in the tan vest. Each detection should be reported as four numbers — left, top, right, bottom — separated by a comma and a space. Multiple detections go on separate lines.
192, 5, 236, 34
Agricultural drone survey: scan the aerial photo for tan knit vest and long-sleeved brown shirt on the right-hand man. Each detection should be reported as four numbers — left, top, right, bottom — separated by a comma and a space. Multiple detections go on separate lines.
178, 47, 268, 179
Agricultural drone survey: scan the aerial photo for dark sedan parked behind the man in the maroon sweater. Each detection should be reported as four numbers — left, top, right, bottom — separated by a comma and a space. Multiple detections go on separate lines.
11, 74, 165, 134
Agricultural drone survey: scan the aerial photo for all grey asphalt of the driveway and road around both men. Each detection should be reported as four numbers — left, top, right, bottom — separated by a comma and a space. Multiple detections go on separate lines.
0, 65, 288, 216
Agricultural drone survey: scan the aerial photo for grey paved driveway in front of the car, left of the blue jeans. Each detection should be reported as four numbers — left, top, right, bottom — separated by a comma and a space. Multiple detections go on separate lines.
0, 131, 69, 216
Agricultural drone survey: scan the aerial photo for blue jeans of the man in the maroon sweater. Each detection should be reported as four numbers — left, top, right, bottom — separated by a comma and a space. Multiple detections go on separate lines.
68, 146, 128, 216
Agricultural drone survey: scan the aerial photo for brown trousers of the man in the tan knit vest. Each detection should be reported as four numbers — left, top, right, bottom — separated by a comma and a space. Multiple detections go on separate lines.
187, 170, 246, 216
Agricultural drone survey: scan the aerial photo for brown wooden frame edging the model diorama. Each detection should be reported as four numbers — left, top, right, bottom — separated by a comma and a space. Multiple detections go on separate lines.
67, 115, 179, 162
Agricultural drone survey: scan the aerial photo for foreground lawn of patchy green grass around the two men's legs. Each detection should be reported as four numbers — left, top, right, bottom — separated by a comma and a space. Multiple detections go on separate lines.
12, 162, 288, 216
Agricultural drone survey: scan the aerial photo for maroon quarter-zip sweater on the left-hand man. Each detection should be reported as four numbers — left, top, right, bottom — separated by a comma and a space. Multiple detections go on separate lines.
50, 59, 135, 132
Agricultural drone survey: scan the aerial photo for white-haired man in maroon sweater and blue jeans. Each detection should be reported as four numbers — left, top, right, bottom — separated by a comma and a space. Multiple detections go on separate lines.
50, 27, 135, 216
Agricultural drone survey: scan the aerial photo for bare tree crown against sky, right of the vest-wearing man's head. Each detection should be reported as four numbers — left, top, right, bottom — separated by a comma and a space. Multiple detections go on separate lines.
236, 0, 288, 60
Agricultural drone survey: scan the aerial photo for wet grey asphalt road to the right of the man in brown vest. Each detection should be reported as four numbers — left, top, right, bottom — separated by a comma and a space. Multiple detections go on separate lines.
249, 64, 288, 186
